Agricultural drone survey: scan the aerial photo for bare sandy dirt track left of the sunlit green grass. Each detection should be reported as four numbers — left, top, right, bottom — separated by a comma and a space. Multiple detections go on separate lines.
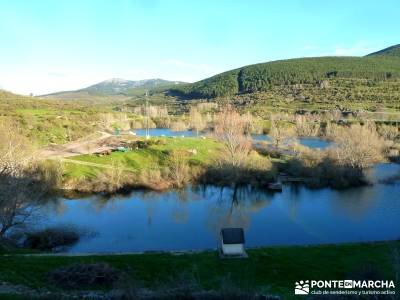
39, 131, 112, 159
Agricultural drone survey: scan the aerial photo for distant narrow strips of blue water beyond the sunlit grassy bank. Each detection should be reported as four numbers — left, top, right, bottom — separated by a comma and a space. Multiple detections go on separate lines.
134, 128, 331, 149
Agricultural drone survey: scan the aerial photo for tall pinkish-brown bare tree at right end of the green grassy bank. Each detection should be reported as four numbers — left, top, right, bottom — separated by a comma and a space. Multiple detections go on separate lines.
214, 106, 251, 166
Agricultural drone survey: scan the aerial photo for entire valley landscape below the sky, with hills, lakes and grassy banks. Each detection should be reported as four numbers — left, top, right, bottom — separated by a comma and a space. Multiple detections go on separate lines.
0, 45, 400, 299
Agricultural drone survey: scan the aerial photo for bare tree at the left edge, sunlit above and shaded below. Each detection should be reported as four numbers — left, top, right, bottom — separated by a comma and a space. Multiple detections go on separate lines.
0, 122, 59, 238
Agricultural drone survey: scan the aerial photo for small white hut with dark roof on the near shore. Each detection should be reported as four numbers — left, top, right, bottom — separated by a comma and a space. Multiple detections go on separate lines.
221, 228, 247, 257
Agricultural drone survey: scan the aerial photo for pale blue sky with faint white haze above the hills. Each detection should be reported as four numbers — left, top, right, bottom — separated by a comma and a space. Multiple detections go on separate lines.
0, 0, 400, 95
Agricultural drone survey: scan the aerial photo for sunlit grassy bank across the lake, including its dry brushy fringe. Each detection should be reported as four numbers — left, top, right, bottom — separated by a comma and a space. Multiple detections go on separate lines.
63, 138, 225, 192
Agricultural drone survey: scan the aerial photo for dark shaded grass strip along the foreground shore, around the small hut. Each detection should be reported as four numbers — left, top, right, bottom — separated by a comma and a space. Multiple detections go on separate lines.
0, 241, 400, 299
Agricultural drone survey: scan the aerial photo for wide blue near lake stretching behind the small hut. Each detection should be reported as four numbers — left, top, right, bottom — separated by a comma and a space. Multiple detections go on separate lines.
38, 164, 400, 252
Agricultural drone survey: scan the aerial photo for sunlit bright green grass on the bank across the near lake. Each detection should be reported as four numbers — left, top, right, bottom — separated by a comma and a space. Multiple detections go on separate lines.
64, 138, 221, 177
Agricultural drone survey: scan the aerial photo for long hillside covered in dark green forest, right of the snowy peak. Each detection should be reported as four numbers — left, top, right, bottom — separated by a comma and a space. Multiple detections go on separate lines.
170, 47, 400, 98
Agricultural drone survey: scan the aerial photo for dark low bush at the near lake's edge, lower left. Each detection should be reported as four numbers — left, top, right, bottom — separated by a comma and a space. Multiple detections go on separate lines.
24, 228, 79, 250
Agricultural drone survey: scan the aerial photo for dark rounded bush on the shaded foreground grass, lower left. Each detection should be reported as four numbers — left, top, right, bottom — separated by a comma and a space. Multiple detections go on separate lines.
48, 263, 121, 289
